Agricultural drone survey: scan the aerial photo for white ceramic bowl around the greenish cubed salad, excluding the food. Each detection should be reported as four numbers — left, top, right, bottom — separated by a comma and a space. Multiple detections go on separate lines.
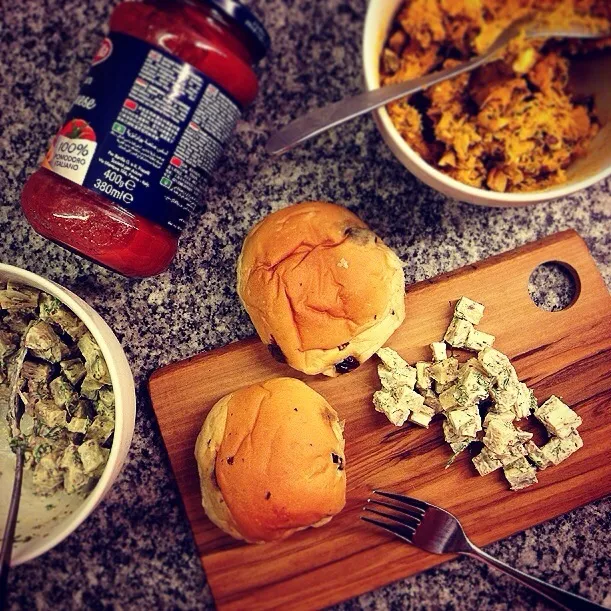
0, 263, 136, 566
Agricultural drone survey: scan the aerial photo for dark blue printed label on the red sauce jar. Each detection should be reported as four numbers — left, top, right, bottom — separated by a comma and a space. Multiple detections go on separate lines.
43, 32, 240, 231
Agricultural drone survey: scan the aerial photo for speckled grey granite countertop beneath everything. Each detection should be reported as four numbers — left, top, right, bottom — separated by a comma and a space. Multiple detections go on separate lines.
0, 0, 611, 610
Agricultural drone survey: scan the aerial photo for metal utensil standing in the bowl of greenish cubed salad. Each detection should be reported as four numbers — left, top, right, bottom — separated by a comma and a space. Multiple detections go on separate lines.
0, 323, 34, 609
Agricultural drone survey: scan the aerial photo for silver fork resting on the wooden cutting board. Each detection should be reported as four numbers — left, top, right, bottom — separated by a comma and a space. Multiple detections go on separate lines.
361, 490, 605, 611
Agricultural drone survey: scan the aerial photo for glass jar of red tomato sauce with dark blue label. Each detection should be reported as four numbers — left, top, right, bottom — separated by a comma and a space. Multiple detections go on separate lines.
21, 0, 269, 277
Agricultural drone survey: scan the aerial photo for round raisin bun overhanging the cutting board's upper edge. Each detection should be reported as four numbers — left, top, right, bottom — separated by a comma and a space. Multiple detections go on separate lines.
237, 202, 405, 376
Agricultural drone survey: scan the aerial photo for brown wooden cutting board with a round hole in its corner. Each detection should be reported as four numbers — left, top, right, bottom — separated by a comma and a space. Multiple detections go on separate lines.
149, 231, 611, 610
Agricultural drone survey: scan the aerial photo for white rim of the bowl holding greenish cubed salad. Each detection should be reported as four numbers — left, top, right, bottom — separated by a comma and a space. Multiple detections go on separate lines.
0, 263, 136, 566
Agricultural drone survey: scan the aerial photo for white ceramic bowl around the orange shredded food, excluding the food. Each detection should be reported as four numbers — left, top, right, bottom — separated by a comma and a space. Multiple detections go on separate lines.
363, 0, 611, 206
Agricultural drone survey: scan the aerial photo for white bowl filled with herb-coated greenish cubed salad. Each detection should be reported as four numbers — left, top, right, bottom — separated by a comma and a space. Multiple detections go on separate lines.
0, 264, 136, 565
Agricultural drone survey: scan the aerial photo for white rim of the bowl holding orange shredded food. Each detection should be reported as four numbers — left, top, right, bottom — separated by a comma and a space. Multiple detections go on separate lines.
362, 0, 611, 206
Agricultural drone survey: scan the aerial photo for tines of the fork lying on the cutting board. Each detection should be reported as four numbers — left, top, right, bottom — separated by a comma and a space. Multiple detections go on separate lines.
361, 490, 428, 543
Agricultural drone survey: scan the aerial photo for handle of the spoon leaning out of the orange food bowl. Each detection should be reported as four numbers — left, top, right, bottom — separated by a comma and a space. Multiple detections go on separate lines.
265, 52, 493, 155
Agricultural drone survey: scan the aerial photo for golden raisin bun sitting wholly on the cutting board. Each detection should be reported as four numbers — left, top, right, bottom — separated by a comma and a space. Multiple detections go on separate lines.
195, 378, 346, 543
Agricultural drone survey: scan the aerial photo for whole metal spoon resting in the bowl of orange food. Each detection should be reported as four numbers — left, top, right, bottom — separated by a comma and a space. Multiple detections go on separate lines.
265, 17, 609, 155
